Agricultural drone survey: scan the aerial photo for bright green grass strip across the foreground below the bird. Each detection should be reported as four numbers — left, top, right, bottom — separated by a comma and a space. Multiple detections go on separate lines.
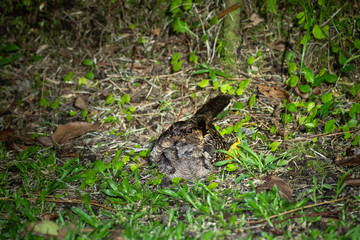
0, 141, 359, 239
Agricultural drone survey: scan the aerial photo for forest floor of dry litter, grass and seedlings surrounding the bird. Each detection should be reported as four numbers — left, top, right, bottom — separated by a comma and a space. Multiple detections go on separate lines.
0, 1, 360, 239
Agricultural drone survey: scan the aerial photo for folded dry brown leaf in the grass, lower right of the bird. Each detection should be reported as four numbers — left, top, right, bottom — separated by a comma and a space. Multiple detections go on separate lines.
256, 175, 293, 202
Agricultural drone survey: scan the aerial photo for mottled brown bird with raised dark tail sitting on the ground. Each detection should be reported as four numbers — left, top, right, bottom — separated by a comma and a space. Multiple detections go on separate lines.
149, 95, 231, 179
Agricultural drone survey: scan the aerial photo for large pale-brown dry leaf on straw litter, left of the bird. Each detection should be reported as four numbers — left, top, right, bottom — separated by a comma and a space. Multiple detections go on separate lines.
51, 121, 99, 144
